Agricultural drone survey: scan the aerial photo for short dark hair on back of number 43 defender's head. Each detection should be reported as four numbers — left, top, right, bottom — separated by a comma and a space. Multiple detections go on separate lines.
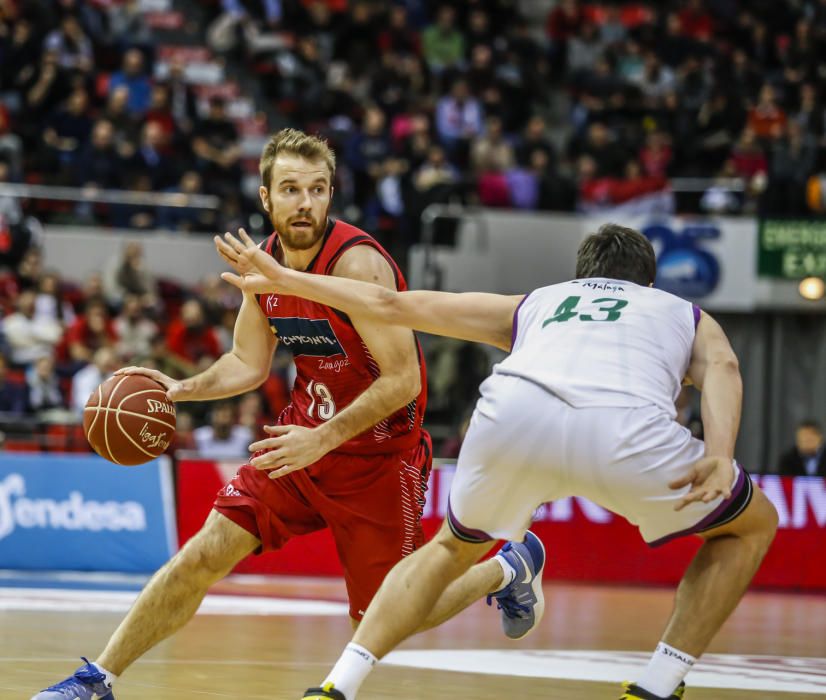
576, 224, 657, 287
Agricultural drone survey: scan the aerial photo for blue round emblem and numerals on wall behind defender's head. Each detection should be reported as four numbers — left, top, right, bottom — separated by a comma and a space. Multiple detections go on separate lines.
641, 223, 720, 299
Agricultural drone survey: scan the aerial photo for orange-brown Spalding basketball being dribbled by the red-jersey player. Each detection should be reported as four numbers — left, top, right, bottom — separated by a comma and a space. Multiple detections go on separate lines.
83, 374, 175, 466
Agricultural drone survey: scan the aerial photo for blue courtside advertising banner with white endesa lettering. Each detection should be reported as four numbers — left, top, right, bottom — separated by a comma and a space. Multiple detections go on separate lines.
0, 453, 177, 573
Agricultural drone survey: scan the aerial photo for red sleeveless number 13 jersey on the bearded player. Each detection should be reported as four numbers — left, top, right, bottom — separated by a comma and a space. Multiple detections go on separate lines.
258, 219, 427, 454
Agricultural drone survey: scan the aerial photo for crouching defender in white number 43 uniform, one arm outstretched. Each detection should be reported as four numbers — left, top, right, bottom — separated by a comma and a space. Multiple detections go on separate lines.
220, 224, 777, 700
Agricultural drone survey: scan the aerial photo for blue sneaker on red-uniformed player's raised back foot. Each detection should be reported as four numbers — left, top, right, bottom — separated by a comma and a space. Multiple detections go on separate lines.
488, 530, 545, 639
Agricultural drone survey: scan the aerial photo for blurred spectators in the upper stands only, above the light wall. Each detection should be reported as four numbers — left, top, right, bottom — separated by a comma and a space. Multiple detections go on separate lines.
0, 0, 826, 246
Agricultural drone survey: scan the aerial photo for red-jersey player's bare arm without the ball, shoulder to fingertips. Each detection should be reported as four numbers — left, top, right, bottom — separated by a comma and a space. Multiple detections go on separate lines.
250, 245, 421, 479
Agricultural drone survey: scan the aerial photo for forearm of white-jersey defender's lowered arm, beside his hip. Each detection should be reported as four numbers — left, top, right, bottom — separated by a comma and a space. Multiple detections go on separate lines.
700, 359, 743, 458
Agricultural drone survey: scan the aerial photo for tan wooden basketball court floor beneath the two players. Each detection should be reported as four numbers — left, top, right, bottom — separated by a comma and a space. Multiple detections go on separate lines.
0, 579, 826, 700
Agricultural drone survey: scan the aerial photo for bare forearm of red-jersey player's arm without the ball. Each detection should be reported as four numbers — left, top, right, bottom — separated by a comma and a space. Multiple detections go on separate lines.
317, 374, 421, 452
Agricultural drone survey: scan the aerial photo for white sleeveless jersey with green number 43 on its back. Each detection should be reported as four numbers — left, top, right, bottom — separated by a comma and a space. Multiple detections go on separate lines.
494, 279, 696, 417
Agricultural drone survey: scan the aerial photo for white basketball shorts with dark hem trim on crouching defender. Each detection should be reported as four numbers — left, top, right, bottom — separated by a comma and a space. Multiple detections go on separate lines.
448, 374, 752, 546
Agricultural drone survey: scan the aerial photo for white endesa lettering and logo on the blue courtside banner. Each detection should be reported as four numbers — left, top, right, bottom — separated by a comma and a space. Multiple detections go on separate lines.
0, 473, 146, 540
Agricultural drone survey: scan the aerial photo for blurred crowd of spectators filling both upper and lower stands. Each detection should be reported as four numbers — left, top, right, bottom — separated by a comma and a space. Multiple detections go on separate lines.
0, 0, 826, 470
